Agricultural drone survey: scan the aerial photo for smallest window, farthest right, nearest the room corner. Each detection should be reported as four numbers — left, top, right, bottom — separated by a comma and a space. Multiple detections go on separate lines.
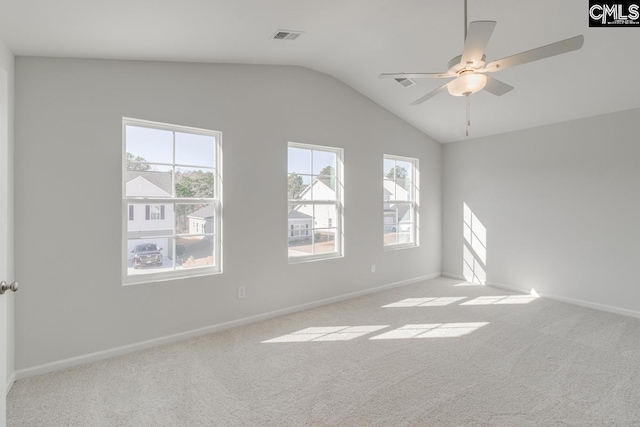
382, 155, 420, 248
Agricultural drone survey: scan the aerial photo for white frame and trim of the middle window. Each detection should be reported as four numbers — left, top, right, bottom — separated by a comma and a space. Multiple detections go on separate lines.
286, 142, 344, 264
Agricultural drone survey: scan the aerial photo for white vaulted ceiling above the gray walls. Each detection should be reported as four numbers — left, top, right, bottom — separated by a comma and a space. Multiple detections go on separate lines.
0, 0, 640, 142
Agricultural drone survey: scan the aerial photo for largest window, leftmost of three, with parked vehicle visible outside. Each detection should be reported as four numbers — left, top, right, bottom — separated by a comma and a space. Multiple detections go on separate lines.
122, 119, 222, 284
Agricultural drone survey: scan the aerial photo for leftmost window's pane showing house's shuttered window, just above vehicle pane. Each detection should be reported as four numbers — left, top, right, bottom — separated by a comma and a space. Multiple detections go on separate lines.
127, 202, 174, 238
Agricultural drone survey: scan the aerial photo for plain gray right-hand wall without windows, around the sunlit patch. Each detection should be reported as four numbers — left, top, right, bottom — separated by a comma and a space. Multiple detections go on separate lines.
442, 109, 640, 314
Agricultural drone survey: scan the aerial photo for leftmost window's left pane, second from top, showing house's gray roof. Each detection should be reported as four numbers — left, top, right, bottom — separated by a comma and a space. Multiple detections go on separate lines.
125, 163, 172, 197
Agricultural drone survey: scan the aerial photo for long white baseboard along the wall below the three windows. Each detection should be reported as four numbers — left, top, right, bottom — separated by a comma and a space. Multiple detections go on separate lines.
12, 272, 442, 381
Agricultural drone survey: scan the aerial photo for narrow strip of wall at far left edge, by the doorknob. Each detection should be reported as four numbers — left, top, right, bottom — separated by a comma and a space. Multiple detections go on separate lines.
0, 39, 16, 390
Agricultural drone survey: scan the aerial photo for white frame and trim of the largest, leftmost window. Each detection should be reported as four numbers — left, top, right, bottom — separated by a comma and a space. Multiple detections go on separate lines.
120, 117, 223, 286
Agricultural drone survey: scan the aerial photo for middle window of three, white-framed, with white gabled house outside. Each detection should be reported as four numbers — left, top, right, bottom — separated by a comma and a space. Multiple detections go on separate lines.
287, 143, 343, 262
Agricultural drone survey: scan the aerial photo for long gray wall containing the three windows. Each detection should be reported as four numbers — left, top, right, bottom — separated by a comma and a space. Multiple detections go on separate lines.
15, 58, 441, 369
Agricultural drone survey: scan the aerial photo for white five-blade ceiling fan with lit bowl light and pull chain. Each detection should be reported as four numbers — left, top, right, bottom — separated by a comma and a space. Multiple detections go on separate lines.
379, 0, 584, 136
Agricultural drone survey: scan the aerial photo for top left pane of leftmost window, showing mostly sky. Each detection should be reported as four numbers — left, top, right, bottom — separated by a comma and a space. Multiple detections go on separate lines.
125, 126, 173, 163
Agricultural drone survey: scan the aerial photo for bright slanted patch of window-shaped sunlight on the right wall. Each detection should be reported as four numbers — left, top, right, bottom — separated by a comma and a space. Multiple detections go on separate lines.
462, 203, 487, 285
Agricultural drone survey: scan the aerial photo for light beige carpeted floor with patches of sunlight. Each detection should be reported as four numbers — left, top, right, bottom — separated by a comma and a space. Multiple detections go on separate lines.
7, 278, 640, 427
